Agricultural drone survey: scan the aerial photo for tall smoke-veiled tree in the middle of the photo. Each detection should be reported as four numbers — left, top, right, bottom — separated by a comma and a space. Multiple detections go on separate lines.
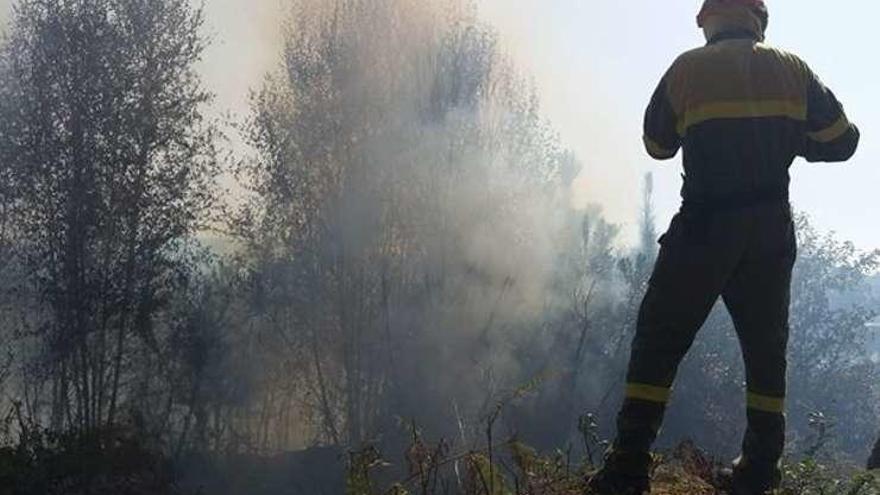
233, 0, 570, 445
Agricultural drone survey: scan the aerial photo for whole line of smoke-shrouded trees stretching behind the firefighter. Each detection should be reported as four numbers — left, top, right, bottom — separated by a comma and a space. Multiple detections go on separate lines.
0, 0, 880, 488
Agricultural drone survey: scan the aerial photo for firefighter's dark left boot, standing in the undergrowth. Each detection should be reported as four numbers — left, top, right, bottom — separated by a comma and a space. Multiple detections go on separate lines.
586, 451, 651, 495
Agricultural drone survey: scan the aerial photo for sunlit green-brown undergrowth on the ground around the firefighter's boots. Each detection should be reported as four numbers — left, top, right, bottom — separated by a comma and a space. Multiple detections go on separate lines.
346, 439, 880, 495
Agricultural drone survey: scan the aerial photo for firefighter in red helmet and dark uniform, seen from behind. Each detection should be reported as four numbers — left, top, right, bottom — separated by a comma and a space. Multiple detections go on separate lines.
589, 0, 859, 495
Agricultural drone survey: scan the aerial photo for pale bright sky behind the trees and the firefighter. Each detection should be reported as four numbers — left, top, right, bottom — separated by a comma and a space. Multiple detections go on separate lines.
0, 0, 880, 249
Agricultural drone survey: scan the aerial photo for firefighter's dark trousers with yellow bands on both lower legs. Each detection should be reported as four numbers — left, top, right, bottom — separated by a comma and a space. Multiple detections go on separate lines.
611, 201, 797, 476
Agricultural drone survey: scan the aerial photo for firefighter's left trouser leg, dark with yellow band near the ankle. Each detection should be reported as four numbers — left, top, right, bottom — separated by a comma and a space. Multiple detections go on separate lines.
606, 213, 741, 476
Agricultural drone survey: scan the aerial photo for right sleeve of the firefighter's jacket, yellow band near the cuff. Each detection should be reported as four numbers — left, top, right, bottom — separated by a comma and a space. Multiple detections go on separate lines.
803, 71, 860, 162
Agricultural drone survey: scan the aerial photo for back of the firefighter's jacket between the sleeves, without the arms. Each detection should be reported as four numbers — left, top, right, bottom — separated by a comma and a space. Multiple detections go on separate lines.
668, 39, 810, 201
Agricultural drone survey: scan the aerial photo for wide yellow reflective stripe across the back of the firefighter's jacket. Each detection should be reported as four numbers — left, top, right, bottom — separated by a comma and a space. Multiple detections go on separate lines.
678, 100, 807, 136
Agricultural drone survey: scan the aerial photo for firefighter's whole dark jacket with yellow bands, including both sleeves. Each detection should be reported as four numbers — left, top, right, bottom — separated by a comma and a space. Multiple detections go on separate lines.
645, 33, 859, 203
